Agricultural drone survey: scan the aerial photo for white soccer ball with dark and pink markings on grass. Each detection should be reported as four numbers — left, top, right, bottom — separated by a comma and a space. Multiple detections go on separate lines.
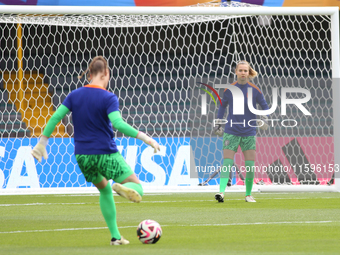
137, 220, 162, 244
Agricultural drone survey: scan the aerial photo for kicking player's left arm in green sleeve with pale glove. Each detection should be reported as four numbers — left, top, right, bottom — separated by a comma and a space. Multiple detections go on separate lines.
31, 105, 70, 162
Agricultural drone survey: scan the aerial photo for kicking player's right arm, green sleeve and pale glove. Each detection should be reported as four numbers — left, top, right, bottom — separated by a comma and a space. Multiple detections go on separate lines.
108, 111, 160, 153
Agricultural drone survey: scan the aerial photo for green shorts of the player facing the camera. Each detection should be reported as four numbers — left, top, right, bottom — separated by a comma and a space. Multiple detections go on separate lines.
223, 133, 256, 151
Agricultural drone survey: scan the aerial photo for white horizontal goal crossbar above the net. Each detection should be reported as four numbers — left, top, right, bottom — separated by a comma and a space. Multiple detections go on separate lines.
0, 5, 339, 15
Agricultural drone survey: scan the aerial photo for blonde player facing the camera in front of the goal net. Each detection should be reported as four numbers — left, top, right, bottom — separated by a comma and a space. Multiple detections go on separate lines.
214, 60, 269, 202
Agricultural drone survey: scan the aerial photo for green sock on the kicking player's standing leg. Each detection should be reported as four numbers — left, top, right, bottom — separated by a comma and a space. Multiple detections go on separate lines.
99, 183, 120, 239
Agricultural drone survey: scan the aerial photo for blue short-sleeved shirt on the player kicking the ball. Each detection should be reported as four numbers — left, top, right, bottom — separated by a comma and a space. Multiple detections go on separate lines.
63, 85, 119, 155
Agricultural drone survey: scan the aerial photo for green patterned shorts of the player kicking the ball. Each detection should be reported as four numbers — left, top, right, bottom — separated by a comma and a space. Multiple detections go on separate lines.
76, 151, 133, 183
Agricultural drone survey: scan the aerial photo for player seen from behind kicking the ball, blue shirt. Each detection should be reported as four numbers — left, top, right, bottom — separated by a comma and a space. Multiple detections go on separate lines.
32, 56, 160, 245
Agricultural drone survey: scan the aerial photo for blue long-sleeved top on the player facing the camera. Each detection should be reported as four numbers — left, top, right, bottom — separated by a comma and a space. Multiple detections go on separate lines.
217, 82, 269, 137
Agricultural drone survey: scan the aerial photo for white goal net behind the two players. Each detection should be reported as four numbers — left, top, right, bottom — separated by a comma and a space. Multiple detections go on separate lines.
0, 2, 339, 193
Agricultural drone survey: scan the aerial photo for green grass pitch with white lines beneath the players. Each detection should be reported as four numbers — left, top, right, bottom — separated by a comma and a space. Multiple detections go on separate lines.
0, 193, 340, 255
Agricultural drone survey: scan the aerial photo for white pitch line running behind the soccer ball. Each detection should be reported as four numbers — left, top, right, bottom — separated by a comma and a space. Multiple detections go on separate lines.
0, 221, 338, 234
